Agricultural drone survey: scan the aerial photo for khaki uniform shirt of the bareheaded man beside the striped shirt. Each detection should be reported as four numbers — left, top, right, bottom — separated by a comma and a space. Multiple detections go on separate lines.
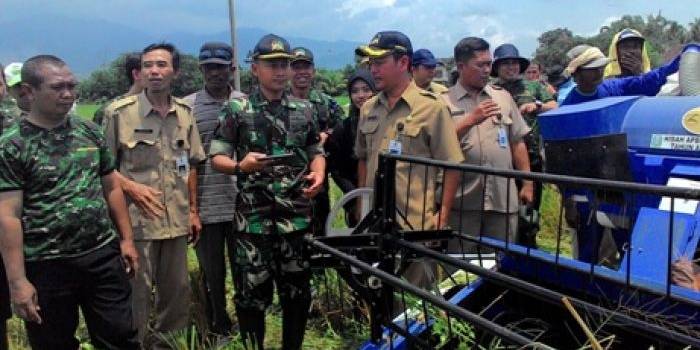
103, 91, 205, 240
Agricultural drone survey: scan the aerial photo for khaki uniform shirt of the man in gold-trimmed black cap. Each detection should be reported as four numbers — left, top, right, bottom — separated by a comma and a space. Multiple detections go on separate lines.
355, 82, 464, 230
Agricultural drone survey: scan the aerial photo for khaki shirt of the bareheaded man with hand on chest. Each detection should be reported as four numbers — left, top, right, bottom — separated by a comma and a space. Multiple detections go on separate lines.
441, 83, 530, 213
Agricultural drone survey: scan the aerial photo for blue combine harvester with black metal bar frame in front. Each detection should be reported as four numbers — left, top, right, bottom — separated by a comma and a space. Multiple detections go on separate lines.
309, 93, 700, 350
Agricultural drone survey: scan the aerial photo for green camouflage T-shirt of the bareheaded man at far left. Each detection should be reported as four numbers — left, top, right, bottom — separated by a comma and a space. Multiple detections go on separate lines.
0, 116, 116, 261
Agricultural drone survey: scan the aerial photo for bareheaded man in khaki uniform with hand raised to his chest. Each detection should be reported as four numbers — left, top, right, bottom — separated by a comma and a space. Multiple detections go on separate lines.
442, 37, 533, 252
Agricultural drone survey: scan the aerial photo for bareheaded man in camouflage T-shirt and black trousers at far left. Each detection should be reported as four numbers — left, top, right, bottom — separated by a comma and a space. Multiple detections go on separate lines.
0, 55, 139, 349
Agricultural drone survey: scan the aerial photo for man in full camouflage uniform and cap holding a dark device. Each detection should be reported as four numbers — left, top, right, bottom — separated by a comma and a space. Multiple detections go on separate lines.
209, 34, 326, 349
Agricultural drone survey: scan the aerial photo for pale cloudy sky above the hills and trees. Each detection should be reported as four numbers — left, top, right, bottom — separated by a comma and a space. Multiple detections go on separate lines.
0, 0, 700, 56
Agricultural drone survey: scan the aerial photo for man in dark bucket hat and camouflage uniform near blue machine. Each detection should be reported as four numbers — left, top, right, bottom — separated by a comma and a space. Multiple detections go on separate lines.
491, 44, 557, 248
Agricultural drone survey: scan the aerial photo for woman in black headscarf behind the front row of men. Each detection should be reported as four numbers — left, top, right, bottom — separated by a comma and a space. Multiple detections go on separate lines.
326, 68, 377, 227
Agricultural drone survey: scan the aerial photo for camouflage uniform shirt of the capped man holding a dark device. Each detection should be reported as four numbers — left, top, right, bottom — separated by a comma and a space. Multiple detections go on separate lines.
209, 91, 323, 234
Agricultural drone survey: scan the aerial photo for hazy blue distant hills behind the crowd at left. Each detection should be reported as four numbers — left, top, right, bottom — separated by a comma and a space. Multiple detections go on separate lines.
0, 18, 359, 76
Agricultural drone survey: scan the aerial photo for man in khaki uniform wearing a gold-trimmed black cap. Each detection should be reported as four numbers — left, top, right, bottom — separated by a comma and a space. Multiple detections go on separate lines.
355, 31, 464, 286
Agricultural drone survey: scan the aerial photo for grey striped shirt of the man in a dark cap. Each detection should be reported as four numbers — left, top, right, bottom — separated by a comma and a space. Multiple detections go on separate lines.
184, 88, 246, 224
